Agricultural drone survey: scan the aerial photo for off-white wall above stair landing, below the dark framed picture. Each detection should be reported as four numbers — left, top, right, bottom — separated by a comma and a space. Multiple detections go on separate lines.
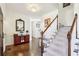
58, 3, 74, 26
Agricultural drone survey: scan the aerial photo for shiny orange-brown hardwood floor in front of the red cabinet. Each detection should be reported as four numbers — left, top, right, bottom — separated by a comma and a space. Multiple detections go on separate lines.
4, 43, 30, 56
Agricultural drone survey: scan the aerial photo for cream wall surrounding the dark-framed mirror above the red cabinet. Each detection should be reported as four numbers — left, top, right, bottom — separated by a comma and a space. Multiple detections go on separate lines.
4, 10, 30, 45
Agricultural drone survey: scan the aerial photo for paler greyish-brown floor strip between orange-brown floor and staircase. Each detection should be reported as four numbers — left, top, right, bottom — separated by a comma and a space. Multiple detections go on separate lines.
30, 37, 41, 56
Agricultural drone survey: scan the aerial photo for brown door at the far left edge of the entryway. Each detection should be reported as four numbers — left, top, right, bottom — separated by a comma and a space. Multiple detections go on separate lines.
0, 8, 3, 56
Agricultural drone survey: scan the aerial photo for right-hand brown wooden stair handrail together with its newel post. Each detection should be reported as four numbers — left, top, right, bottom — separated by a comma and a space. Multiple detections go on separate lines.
67, 14, 77, 56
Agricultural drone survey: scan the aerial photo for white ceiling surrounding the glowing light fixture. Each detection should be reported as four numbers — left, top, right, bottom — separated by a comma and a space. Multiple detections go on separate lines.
6, 3, 58, 17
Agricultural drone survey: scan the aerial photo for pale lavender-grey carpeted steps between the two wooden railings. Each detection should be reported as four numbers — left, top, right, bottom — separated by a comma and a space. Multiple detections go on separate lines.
43, 27, 70, 56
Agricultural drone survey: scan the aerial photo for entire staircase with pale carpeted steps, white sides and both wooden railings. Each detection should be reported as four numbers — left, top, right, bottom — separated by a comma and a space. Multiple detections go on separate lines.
41, 14, 79, 56
